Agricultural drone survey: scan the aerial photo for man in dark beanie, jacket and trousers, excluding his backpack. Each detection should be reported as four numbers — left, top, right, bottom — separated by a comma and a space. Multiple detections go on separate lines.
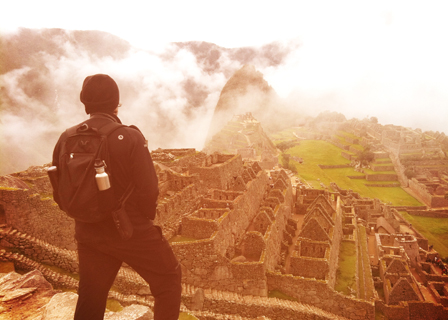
53, 74, 181, 320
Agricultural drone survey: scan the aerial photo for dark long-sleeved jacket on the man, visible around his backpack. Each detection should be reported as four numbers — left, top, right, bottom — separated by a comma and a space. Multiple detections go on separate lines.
53, 113, 159, 241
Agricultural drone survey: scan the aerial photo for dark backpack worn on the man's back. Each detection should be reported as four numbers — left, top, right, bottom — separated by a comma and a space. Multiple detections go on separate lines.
53, 122, 127, 223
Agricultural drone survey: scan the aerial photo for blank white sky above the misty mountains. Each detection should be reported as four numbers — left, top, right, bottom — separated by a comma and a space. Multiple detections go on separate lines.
0, 0, 448, 133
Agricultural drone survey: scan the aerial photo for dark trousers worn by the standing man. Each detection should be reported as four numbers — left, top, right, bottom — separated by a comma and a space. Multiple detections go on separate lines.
75, 226, 182, 320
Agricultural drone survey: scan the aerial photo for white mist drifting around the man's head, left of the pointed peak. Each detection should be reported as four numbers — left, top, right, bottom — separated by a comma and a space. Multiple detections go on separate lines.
0, 30, 245, 174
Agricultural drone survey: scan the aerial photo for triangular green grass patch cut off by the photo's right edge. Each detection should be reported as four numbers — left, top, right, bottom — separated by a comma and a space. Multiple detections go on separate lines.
401, 212, 448, 258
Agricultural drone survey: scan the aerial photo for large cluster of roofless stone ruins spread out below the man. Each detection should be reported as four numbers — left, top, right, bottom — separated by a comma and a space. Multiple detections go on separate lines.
0, 149, 448, 319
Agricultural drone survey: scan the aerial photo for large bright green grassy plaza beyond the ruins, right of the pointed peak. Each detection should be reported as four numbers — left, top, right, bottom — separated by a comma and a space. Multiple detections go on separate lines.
287, 140, 422, 206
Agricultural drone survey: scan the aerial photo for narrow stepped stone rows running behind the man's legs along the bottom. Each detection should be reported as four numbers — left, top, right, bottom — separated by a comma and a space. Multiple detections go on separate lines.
0, 228, 346, 320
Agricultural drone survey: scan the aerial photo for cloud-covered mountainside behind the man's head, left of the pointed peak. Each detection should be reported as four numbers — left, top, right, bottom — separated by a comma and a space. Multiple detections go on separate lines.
0, 29, 293, 175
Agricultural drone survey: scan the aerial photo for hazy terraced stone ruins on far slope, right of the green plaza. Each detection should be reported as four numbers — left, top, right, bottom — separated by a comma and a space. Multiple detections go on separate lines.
340, 120, 448, 208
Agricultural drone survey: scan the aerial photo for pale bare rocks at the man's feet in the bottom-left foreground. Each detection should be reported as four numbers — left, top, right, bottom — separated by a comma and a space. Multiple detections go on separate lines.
0, 270, 154, 320
